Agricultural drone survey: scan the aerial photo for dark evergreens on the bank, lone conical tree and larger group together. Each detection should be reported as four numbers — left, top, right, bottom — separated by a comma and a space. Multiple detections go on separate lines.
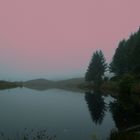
85, 29, 140, 93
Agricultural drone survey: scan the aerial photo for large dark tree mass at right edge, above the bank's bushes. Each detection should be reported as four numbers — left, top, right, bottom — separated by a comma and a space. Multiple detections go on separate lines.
110, 29, 140, 76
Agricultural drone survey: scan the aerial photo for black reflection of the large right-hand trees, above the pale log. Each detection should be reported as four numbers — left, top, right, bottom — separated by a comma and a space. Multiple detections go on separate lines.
110, 94, 140, 130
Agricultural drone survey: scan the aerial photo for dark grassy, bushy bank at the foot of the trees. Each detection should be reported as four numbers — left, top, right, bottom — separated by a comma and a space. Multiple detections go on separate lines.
77, 74, 140, 95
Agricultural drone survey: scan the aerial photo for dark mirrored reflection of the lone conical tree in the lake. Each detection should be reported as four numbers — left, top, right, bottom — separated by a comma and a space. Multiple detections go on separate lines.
85, 91, 107, 125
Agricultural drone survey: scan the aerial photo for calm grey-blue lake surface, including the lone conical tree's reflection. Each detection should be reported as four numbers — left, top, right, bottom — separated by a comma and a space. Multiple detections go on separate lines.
0, 88, 115, 140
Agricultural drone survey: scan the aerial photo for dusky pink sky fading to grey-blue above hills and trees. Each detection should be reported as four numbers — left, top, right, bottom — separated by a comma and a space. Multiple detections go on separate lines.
0, 0, 140, 80
